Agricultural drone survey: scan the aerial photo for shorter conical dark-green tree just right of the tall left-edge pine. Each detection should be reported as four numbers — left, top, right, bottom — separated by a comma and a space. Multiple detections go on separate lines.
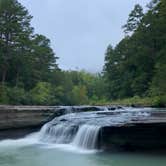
20, 35, 59, 89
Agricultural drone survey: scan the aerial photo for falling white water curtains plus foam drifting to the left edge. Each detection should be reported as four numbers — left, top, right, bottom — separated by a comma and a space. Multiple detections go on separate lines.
0, 123, 100, 153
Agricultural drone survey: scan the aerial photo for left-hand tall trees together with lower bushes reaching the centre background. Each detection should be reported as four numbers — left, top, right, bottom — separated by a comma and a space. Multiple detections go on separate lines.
0, 0, 105, 105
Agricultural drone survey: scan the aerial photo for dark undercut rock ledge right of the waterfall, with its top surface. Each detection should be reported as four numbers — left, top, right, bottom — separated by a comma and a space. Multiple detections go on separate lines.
100, 110, 166, 151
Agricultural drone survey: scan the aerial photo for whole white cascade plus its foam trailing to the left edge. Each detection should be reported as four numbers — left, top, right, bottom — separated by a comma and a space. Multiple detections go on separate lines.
0, 109, 150, 152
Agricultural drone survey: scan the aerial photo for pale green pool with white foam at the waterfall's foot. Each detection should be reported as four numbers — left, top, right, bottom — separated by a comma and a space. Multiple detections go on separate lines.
0, 138, 166, 166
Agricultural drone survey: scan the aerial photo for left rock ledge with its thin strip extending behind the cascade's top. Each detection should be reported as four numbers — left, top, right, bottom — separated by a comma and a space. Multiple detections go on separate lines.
0, 105, 120, 130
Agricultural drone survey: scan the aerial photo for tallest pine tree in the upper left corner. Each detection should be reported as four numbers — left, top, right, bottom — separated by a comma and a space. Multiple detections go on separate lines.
0, 0, 33, 84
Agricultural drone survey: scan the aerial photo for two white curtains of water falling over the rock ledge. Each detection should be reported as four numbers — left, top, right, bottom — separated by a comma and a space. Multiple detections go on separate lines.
40, 122, 100, 149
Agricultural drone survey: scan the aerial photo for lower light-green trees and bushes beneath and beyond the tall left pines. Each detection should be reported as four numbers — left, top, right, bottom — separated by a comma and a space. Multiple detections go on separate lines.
0, 70, 106, 105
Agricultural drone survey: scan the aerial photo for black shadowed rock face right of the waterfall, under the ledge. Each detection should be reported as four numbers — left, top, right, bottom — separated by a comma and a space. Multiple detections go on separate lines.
100, 123, 166, 151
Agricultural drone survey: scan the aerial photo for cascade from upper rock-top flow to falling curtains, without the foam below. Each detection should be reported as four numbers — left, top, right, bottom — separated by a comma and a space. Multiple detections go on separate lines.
39, 110, 149, 150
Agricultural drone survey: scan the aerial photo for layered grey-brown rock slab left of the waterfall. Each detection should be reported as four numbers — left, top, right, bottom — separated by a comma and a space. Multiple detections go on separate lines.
0, 106, 56, 130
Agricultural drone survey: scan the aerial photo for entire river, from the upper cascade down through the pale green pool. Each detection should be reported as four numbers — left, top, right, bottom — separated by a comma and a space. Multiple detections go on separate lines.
0, 107, 166, 166
